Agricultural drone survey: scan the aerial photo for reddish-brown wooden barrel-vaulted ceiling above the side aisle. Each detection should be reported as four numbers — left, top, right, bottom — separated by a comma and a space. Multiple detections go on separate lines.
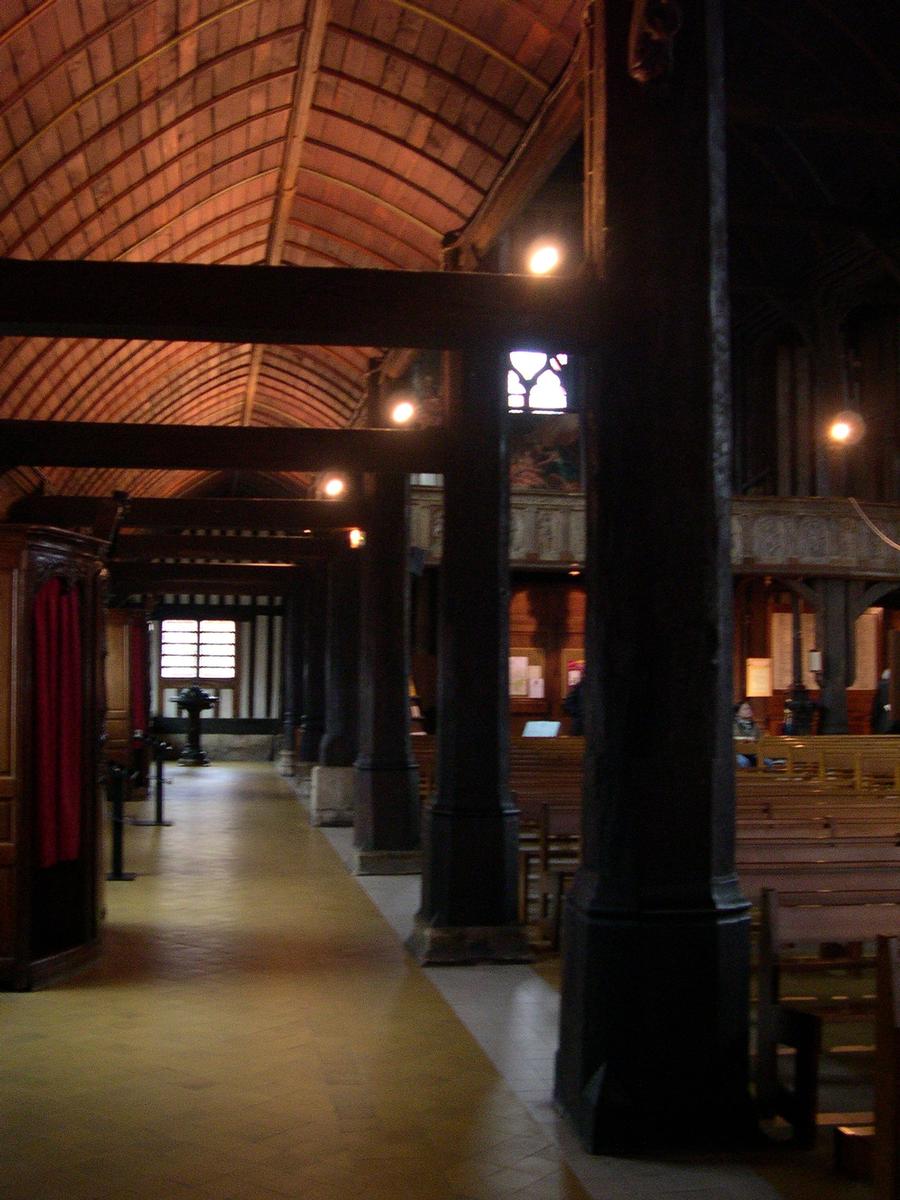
0, 0, 582, 496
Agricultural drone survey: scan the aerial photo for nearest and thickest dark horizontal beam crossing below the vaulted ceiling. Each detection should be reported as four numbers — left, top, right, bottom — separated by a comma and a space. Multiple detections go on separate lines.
0, 258, 601, 350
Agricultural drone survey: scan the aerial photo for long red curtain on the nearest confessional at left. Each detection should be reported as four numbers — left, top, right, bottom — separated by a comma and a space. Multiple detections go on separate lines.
35, 578, 83, 866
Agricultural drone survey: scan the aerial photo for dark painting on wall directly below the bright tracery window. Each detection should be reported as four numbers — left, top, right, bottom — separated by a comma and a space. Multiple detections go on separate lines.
509, 413, 582, 492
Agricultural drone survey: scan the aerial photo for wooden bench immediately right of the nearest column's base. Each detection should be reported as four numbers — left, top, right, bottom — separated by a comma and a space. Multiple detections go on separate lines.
755, 888, 900, 1146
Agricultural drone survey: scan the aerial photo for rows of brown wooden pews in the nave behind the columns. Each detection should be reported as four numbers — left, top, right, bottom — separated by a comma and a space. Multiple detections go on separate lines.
414, 736, 900, 1180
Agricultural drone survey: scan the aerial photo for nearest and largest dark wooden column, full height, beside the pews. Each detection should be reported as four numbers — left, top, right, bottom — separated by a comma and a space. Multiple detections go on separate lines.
556, 0, 752, 1153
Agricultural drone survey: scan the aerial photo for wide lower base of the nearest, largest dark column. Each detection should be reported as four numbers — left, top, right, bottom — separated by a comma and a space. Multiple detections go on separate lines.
554, 878, 757, 1154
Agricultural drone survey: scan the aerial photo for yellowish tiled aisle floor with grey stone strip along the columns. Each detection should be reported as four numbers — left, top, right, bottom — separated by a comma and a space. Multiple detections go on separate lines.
0, 763, 869, 1200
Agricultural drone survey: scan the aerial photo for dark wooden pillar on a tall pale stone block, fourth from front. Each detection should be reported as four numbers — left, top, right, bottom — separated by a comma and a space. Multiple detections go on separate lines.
310, 547, 360, 824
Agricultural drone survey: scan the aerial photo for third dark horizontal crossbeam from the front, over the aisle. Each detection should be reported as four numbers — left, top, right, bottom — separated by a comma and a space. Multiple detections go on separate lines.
10, 496, 365, 530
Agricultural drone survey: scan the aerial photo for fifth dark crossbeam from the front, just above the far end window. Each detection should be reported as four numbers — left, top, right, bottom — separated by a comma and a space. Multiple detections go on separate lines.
109, 563, 304, 595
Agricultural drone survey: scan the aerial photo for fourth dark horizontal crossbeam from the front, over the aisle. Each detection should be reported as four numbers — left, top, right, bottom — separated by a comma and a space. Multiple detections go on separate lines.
110, 533, 336, 563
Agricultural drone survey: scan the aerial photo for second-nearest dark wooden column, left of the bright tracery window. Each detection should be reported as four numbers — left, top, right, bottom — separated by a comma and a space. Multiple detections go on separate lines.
409, 348, 528, 962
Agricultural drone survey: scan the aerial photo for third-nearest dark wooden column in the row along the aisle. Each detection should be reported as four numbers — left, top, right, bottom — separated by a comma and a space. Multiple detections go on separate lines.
355, 474, 421, 875
